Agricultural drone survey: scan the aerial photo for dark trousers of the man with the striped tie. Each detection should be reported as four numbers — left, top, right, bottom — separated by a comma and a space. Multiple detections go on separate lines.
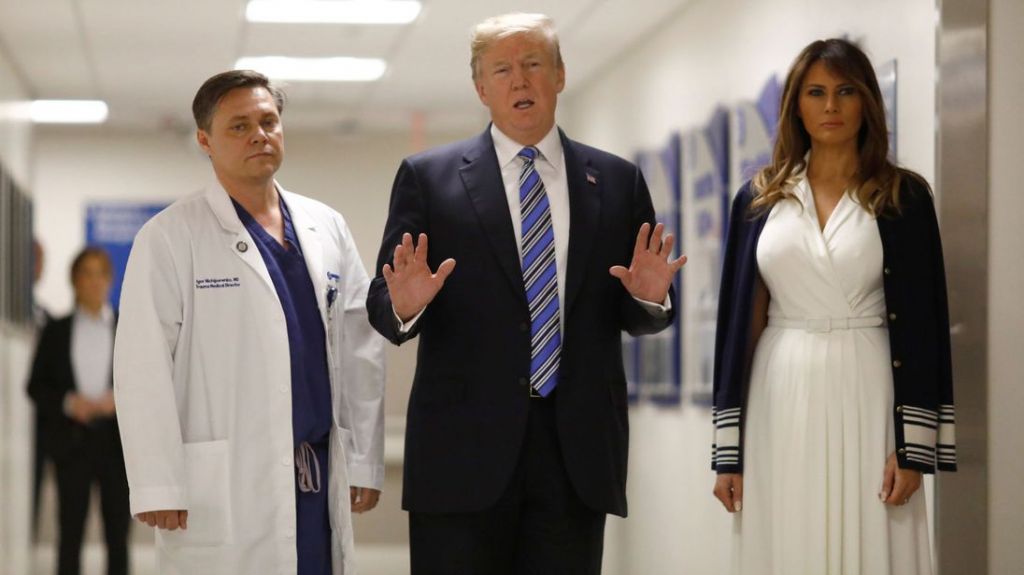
409, 398, 605, 575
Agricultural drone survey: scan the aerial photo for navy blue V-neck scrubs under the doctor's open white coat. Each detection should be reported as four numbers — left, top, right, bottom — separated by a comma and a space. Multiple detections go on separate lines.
231, 200, 332, 575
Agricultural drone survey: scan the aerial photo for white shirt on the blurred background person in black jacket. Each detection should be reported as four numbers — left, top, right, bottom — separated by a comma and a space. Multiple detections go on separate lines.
71, 305, 114, 400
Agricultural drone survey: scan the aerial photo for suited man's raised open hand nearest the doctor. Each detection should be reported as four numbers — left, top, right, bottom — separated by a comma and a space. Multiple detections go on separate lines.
382, 233, 455, 322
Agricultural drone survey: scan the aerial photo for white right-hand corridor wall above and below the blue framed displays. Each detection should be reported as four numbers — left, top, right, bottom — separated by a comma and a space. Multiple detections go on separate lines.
560, 0, 936, 575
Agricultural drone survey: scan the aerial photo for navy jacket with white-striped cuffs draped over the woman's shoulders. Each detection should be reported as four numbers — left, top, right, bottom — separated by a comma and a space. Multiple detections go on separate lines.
712, 175, 956, 473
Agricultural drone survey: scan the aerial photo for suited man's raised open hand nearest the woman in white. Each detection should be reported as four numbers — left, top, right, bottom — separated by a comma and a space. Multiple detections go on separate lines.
608, 223, 686, 304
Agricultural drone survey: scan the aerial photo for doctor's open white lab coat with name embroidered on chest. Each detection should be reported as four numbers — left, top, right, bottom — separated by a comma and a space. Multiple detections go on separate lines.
114, 182, 384, 575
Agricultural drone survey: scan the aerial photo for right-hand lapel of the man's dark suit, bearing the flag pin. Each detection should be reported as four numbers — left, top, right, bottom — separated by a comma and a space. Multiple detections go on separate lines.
558, 130, 601, 317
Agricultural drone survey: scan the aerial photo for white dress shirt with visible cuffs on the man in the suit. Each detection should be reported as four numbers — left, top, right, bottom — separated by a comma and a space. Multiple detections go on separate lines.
395, 124, 672, 334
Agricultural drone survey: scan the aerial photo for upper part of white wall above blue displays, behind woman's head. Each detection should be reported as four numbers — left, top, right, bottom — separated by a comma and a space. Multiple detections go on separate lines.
561, 0, 936, 179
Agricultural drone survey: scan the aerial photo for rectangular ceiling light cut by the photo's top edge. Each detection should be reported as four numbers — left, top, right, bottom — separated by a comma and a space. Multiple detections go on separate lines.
246, 0, 422, 24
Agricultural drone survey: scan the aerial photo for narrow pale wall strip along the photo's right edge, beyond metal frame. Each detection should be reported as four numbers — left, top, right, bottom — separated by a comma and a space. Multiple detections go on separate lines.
988, 0, 1024, 575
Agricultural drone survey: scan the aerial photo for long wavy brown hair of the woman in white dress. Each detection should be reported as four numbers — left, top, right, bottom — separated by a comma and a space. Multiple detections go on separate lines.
751, 38, 928, 216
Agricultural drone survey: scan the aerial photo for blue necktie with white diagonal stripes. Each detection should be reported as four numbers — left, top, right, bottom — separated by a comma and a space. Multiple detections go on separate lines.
518, 146, 562, 397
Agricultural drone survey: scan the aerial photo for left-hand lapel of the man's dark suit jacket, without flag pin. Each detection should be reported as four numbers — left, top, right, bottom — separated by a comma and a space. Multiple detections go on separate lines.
459, 129, 526, 305
